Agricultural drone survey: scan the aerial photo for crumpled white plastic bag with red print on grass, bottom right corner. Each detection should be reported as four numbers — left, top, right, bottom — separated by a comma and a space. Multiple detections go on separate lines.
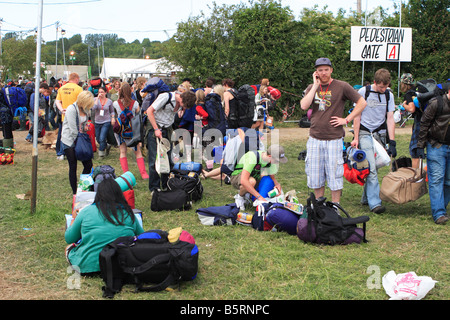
383, 271, 437, 300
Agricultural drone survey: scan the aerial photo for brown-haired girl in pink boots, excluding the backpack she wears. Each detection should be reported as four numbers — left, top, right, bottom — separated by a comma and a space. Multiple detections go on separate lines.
111, 83, 149, 180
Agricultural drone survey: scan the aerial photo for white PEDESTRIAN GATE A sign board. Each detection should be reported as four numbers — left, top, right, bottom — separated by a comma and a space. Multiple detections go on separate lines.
350, 27, 412, 62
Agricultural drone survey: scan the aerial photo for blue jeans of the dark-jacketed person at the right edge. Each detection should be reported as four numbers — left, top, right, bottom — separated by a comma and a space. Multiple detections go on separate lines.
427, 143, 450, 221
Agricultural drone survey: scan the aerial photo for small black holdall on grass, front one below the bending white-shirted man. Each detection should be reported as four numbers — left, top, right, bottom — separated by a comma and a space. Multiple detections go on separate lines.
150, 189, 192, 211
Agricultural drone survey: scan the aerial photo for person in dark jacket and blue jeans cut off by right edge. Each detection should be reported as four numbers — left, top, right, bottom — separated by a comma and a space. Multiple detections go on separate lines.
417, 87, 450, 224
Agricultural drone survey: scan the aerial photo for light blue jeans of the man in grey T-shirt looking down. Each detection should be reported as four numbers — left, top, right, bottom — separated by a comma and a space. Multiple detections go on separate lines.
359, 132, 381, 210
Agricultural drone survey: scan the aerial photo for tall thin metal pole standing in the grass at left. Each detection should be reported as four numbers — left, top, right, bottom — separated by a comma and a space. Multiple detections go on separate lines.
31, 0, 43, 214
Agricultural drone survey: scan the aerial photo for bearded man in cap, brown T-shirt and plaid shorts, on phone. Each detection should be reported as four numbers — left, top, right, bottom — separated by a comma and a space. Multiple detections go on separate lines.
300, 58, 367, 203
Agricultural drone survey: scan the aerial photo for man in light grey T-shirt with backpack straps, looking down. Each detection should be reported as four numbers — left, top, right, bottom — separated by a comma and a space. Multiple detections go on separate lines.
351, 69, 397, 214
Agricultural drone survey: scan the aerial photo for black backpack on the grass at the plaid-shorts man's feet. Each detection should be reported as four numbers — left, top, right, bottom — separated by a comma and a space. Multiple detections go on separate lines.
306, 193, 369, 245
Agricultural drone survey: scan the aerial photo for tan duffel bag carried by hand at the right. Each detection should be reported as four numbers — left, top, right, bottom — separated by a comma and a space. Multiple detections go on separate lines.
380, 162, 428, 204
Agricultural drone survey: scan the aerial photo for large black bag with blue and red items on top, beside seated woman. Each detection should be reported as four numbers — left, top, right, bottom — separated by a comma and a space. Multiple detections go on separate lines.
99, 230, 199, 298
